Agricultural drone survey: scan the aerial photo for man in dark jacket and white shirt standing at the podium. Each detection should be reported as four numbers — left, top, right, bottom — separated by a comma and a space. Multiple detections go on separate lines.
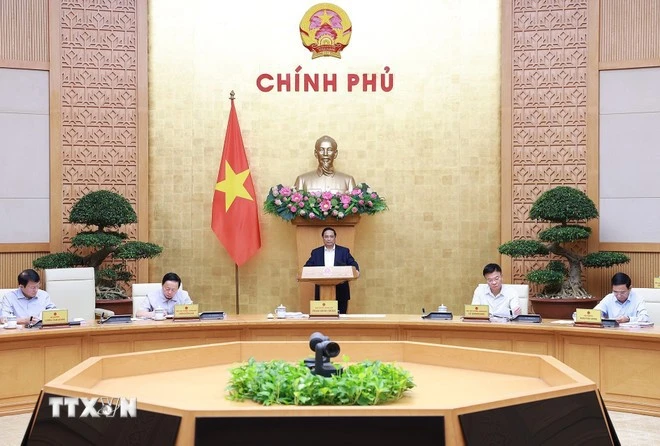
305, 227, 360, 314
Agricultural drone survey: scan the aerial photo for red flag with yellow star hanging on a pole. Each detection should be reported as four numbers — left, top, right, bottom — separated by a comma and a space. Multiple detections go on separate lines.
211, 96, 261, 266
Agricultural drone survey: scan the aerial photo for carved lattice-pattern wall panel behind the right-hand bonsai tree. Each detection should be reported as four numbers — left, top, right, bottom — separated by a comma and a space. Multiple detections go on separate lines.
502, 0, 587, 282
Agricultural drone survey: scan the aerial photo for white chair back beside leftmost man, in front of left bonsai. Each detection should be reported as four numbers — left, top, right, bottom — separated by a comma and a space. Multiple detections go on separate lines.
44, 268, 96, 321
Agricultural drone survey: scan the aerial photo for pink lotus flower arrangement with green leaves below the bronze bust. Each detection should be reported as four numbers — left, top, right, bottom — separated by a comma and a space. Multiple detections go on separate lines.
264, 183, 387, 221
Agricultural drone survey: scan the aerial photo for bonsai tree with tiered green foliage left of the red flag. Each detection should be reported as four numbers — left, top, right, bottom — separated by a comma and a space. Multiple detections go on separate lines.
32, 190, 163, 299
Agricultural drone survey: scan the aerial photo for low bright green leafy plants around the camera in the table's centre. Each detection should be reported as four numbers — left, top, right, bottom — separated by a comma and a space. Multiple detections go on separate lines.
227, 358, 415, 406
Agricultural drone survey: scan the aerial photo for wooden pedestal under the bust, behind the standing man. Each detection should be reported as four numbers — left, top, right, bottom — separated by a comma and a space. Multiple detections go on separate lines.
291, 215, 360, 313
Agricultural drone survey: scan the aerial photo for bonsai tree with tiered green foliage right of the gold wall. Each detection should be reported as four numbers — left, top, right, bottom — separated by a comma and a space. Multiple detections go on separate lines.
499, 186, 630, 298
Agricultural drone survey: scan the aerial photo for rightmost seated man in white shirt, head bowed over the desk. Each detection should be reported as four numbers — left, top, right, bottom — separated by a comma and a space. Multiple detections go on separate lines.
594, 273, 651, 322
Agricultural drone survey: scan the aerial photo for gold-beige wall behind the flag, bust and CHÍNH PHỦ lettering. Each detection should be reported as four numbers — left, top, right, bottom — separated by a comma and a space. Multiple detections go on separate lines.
149, 0, 500, 313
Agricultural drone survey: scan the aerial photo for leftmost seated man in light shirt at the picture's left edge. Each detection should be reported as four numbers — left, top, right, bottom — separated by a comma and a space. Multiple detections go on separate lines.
2, 269, 56, 325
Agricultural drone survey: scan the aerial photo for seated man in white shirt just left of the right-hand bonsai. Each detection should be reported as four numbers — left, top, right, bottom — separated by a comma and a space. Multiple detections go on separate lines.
472, 263, 522, 317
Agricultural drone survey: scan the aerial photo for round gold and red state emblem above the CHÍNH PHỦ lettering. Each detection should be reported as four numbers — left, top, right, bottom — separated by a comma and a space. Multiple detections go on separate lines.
300, 3, 352, 59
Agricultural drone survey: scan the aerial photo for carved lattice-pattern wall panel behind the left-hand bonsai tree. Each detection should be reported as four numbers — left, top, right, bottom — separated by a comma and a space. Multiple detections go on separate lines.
53, 0, 148, 278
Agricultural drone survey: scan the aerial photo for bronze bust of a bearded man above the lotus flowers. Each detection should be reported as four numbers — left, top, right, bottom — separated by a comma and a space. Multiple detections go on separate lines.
294, 135, 355, 193
